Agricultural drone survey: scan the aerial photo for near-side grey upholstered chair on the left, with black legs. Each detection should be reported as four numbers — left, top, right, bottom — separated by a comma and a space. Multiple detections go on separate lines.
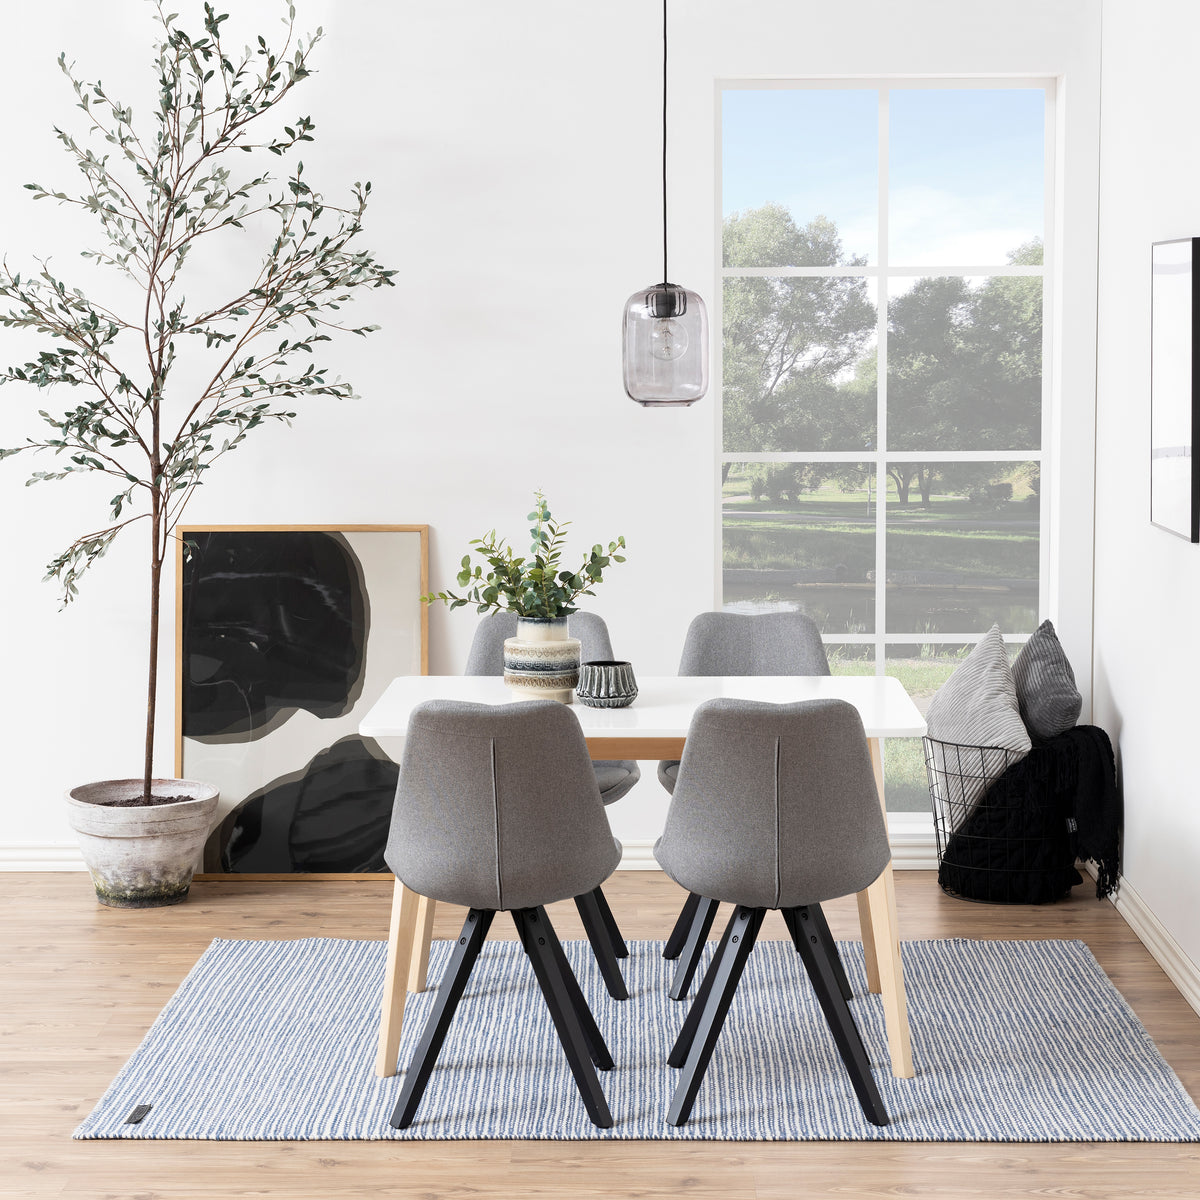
384, 700, 620, 1129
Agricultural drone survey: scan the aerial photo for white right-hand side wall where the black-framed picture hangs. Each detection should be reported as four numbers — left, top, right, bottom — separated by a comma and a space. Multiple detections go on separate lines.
1094, 0, 1200, 971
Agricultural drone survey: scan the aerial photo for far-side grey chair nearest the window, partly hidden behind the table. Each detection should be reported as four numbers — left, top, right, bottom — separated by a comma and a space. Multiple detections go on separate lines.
659, 612, 829, 964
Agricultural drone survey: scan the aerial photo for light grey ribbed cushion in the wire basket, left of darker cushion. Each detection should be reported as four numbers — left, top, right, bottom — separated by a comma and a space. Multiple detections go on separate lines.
925, 625, 1032, 812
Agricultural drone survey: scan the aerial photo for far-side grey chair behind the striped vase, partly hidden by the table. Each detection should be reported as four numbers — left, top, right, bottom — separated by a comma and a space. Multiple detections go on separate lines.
463, 612, 642, 974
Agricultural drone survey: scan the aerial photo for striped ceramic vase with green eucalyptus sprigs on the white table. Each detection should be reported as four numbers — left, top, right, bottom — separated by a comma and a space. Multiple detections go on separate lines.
421, 492, 625, 704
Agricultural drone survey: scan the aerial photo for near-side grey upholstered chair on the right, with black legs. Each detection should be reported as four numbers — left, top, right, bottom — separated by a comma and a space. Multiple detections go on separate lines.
654, 698, 892, 1126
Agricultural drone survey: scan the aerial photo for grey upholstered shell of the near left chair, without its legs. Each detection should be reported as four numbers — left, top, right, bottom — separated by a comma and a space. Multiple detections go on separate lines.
384, 700, 620, 910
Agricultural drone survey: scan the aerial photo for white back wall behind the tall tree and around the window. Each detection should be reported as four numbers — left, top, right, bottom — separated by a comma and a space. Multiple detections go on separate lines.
0, 0, 1098, 859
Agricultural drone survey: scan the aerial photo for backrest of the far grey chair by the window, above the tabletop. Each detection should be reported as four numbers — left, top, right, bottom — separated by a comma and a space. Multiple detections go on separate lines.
679, 612, 829, 676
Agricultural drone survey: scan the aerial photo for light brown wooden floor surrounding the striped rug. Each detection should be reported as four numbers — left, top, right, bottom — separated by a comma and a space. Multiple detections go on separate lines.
0, 871, 1200, 1200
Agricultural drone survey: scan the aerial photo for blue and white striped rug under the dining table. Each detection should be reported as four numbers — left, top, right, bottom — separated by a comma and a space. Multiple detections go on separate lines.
76, 936, 1200, 1141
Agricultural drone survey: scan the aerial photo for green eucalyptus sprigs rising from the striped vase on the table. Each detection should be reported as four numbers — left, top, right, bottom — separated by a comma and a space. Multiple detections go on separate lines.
421, 492, 625, 618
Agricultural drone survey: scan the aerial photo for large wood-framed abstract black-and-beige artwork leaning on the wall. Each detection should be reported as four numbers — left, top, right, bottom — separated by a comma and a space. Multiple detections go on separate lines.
175, 526, 428, 876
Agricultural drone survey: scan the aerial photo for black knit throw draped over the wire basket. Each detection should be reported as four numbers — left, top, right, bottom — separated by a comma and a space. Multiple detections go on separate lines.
937, 725, 1121, 904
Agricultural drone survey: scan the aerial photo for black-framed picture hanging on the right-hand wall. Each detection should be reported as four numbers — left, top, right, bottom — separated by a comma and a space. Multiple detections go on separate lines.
1150, 238, 1200, 541
